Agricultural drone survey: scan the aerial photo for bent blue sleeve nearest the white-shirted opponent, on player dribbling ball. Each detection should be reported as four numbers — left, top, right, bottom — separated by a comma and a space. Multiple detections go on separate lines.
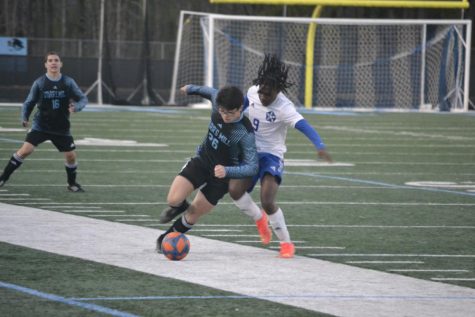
224, 133, 259, 178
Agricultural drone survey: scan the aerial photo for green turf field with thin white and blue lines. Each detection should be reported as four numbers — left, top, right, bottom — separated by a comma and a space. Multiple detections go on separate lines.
0, 107, 475, 316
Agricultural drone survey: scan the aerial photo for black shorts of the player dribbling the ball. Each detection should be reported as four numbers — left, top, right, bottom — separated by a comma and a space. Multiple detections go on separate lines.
178, 157, 229, 206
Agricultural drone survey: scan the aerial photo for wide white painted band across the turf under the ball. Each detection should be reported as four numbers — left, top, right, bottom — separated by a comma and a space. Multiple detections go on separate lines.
0, 203, 475, 317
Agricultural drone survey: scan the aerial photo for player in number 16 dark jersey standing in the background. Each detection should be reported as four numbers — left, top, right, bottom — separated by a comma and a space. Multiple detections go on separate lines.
0, 52, 87, 192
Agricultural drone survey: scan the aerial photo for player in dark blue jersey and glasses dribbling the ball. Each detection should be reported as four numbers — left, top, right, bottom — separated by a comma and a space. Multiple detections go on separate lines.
157, 85, 258, 252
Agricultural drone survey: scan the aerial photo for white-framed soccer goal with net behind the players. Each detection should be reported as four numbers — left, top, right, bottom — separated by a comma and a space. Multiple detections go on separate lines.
169, 11, 471, 111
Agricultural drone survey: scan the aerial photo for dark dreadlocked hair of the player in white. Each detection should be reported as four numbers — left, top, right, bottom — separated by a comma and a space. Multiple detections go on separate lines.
252, 54, 293, 92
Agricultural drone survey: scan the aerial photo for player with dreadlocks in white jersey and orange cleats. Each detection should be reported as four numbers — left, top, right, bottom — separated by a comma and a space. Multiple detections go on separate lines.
229, 54, 332, 258
